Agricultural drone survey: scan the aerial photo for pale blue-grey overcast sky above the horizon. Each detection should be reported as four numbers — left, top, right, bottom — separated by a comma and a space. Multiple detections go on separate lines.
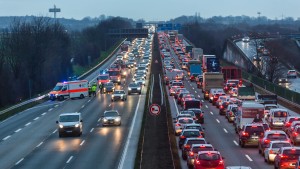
0, 0, 300, 21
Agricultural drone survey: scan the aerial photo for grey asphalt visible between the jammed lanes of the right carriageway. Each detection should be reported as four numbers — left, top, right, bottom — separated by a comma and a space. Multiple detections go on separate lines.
165, 33, 298, 169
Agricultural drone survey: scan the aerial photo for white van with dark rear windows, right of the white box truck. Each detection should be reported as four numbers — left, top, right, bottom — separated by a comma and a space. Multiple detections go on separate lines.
266, 108, 290, 128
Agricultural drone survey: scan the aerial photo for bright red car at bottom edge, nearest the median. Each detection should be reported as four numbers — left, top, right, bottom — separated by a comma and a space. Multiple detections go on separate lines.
194, 151, 225, 169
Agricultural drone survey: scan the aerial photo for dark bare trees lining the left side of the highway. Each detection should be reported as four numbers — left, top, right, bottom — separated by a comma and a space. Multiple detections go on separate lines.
0, 17, 131, 107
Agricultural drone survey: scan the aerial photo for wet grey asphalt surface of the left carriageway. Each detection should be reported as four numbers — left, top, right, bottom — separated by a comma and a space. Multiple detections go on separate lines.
0, 38, 149, 169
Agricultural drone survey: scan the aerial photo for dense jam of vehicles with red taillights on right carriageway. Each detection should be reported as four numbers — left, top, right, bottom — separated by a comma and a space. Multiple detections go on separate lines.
158, 31, 300, 169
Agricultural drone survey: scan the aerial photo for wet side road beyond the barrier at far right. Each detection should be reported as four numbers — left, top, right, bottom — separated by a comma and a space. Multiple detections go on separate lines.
235, 40, 300, 92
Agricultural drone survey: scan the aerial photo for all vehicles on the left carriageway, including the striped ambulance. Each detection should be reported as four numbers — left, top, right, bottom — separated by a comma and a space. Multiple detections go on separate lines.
48, 35, 153, 137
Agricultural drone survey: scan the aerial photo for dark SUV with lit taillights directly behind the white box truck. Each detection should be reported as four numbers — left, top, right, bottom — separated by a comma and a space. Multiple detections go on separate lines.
239, 123, 264, 147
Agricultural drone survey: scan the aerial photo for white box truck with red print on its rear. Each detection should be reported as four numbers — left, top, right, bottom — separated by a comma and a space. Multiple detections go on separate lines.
235, 101, 265, 133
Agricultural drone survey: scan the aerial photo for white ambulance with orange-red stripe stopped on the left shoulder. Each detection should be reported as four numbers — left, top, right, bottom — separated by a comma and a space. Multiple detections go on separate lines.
48, 80, 89, 100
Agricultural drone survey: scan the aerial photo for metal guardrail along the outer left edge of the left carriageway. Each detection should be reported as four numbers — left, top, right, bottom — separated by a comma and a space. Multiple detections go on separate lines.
0, 38, 126, 115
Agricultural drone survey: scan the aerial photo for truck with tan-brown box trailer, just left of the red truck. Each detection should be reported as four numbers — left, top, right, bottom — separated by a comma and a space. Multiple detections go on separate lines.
202, 72, 224, 99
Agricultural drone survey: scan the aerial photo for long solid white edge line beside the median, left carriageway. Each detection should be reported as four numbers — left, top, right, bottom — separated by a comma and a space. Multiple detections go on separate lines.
118, 96, 141, 169
